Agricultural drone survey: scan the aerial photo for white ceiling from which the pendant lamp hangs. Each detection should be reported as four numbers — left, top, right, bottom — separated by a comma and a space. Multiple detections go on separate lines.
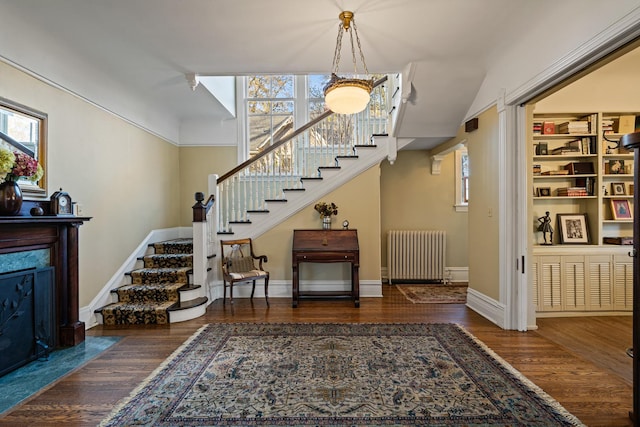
0, 0, 636, 148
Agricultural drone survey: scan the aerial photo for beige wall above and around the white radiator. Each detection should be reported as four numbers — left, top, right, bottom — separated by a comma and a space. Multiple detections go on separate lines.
380, 150, 469, 267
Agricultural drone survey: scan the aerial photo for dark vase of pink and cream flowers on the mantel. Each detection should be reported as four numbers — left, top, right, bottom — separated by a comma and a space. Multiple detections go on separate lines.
0, 146, 43, 216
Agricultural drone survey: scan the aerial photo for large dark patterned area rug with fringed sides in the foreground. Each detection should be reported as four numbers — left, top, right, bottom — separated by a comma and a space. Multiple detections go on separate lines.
101, 323, 582, 427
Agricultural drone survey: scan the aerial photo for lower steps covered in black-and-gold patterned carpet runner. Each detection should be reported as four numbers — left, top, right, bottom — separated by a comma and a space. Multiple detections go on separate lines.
96, 239, 207, 325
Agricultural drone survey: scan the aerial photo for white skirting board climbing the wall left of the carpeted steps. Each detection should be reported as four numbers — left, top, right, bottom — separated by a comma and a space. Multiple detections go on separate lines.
79, 227, 192, 329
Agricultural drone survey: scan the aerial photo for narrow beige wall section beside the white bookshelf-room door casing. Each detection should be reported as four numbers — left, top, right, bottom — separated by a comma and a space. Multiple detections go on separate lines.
459, 106, 500, 301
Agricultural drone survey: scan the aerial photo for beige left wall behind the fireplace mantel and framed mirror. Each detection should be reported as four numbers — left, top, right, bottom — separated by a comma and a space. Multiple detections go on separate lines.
0, 62, 180, 307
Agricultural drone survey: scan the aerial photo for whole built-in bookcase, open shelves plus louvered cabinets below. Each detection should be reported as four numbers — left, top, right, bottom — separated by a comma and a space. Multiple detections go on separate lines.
529, 112, 640, 316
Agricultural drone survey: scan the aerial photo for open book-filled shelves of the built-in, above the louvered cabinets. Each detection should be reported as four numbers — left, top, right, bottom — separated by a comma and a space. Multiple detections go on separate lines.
530, 112, 640, 249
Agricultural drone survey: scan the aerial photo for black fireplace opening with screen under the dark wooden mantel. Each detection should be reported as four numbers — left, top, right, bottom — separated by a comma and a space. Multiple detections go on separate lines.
0, 267, 56, 376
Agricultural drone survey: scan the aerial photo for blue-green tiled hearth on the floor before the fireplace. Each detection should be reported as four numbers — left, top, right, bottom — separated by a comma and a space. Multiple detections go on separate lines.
0, 337, 121, 415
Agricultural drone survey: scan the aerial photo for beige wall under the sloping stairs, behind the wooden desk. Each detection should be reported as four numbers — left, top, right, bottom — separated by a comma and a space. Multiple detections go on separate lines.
254, 166, 380, 281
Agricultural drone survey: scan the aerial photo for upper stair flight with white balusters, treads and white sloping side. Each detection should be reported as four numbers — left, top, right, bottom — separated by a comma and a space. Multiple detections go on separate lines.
215, 77, 397, 238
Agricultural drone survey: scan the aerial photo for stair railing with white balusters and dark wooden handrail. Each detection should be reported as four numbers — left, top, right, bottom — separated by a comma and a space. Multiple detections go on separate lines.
215, 76, 388, 233
